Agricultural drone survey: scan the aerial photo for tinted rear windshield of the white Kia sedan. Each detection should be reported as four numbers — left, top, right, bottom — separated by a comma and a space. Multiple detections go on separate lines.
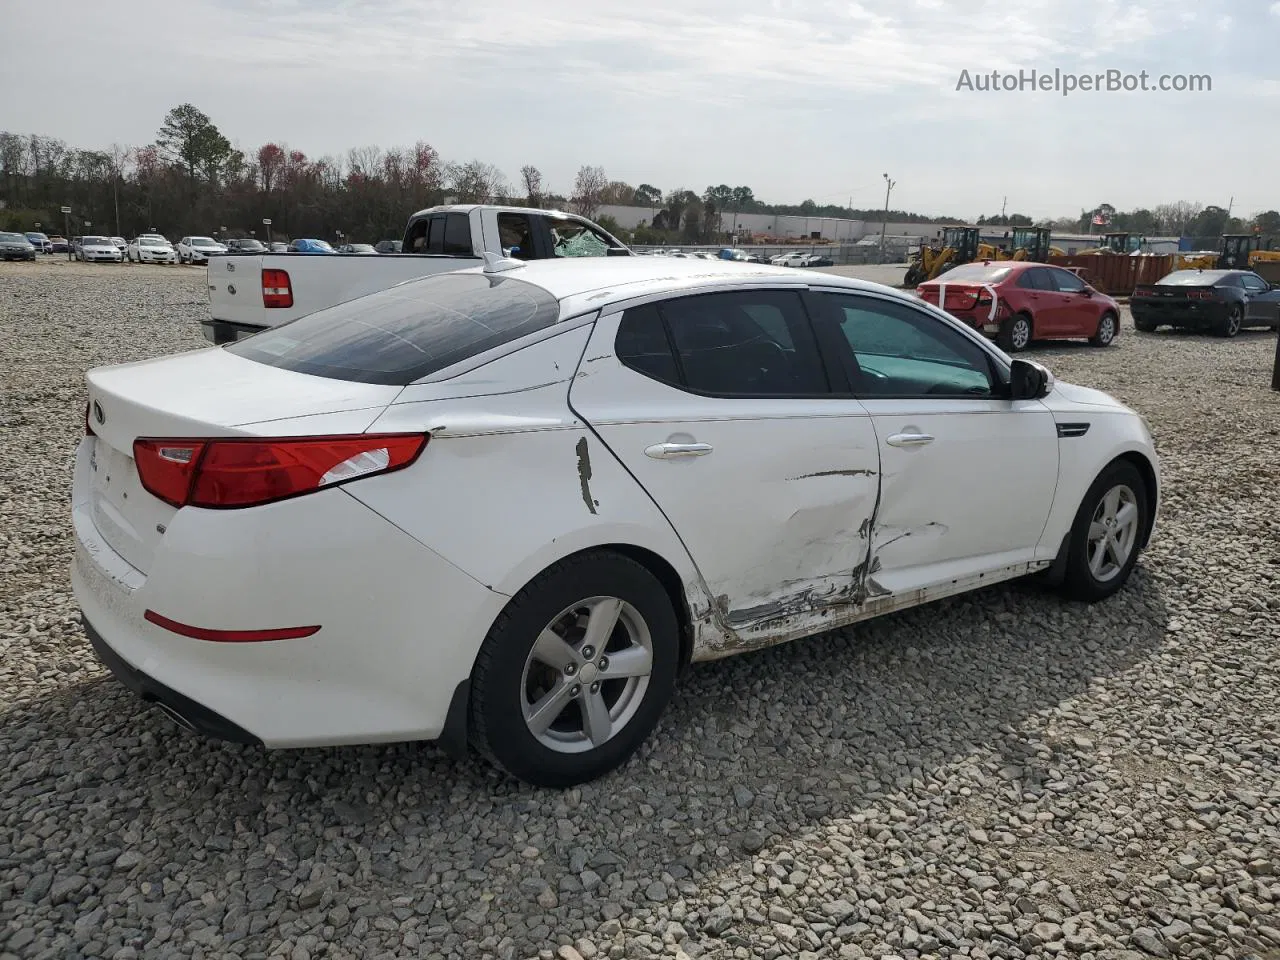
227, 274, 559, 385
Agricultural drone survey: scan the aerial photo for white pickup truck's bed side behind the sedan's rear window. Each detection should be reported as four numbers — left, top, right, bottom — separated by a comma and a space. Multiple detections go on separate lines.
202, 253, 483, 343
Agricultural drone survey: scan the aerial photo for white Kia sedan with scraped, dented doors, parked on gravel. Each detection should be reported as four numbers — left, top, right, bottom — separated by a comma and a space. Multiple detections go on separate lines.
73, 255, 1160, 786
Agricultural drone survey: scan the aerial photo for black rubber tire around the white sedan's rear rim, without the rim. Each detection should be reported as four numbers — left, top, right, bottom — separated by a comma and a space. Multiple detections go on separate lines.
468, 550, 680, 788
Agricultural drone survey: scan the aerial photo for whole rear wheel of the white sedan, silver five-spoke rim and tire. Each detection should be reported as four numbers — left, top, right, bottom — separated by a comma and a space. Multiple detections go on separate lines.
470, 552, 680, 787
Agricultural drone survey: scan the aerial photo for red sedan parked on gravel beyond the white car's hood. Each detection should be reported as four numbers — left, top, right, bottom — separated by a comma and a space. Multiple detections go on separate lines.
915, 260, 1120, 353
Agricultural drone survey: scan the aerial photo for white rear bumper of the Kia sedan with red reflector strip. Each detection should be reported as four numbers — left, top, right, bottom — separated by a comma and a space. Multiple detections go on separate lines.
70, 442, 508, 748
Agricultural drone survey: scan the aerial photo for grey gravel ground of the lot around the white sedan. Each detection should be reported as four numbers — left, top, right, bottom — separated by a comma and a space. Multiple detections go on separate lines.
0, 262, 1280, 960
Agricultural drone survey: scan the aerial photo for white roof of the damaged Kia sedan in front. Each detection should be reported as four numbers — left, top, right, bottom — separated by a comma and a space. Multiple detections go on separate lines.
445, 256, 914, 316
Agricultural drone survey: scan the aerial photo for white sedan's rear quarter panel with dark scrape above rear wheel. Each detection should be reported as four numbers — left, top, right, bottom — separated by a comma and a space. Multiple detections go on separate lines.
344, 326, 707, 616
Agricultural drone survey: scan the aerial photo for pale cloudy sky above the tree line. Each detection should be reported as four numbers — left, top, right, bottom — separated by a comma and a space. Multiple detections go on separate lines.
0, 0, 1280, 218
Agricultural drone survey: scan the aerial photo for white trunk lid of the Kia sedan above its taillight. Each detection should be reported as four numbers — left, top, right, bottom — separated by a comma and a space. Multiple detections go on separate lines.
86, 348, 402, 573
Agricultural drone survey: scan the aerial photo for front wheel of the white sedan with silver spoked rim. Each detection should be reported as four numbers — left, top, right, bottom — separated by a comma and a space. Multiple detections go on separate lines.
1062, 460, 1151, 603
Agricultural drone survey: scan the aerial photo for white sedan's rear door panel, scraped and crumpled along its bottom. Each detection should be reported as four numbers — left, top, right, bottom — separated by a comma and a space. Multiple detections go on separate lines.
570, 294, 879, 649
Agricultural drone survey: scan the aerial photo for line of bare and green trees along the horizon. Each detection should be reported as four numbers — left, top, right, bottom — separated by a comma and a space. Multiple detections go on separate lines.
0, 104, 1280, 243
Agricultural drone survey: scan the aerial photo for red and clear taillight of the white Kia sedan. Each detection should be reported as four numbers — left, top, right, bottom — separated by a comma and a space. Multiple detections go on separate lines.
133, 434, 428, 509
